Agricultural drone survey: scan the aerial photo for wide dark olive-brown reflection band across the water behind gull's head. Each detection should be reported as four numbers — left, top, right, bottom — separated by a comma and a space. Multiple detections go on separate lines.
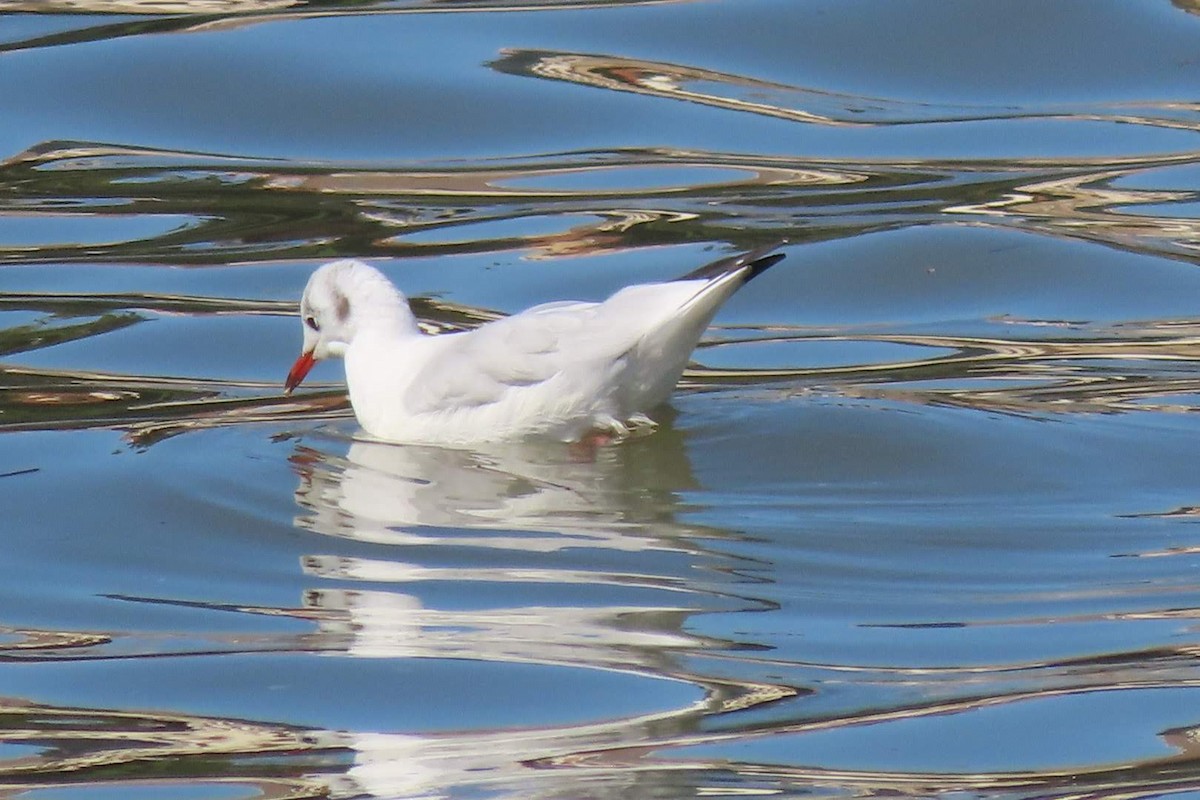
0, 143, 1200, 272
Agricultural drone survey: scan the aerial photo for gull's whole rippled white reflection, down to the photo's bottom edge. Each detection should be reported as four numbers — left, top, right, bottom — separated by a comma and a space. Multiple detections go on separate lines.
284, 423, 797, 796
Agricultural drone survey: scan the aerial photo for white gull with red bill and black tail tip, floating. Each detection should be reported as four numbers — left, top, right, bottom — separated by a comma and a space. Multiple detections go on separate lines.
284, 242, 784, 445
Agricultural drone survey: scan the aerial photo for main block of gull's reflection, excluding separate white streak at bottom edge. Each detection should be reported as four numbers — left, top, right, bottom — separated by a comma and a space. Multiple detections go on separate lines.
285, 426, 760, 680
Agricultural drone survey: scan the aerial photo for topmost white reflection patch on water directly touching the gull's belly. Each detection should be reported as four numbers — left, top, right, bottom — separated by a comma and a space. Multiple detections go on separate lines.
296, 437, 701, 552
